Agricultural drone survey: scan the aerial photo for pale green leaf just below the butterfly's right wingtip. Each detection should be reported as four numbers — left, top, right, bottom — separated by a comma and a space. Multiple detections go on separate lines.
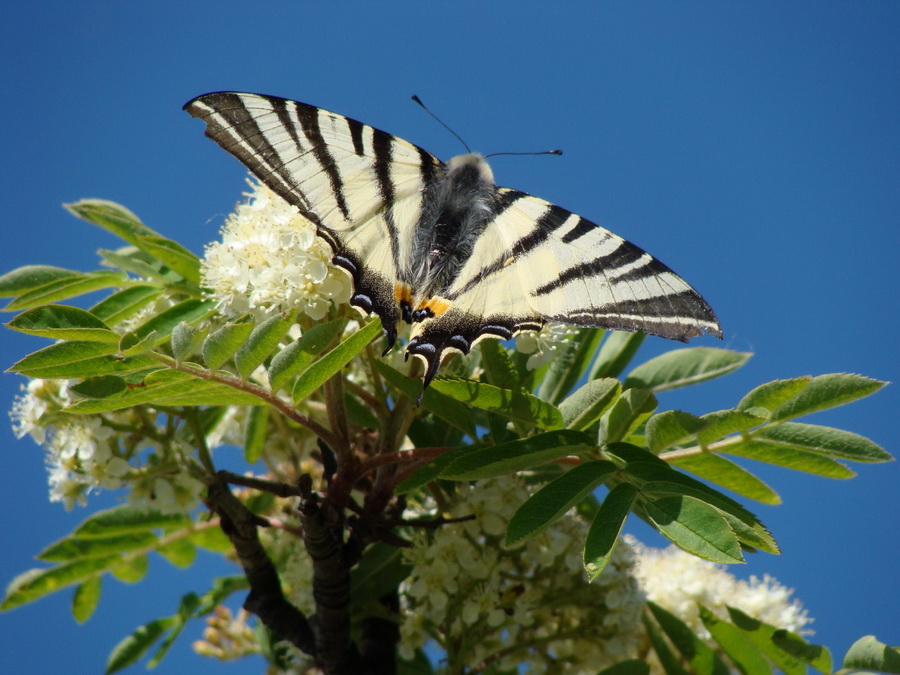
625, 347, 752, 393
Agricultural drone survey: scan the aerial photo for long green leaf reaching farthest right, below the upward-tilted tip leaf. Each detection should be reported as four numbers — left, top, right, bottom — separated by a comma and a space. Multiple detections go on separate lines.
753, 422, 893, 462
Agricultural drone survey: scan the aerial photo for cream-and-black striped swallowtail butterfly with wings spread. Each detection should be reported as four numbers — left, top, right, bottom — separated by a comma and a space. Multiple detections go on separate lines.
184, 92, 722, 398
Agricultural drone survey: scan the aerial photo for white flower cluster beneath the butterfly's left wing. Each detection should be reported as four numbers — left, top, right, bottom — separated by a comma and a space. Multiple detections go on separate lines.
202, 181, 351, 319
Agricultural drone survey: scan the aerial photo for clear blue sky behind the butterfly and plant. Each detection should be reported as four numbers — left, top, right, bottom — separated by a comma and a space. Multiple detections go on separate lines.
0, 1, 900, 673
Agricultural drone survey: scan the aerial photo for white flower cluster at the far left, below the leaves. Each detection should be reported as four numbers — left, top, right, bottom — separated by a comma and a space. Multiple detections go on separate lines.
10, 379, 209, 512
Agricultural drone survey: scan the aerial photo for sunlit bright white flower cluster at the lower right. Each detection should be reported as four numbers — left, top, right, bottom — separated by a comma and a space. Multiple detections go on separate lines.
632, 540, 812, 639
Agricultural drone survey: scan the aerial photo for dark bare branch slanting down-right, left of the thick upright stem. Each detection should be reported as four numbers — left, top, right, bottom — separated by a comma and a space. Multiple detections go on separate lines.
206, 479, 316, 656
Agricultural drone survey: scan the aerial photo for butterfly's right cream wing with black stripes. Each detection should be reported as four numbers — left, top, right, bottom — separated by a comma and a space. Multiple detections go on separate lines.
410, 188, 721, 388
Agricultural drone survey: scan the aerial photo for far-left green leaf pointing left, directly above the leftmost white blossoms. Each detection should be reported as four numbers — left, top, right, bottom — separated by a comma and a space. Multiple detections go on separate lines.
9, 341, 158, 379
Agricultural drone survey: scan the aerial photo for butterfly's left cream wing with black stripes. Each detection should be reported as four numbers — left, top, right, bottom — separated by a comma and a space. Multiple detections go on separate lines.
185, 92, 442, 343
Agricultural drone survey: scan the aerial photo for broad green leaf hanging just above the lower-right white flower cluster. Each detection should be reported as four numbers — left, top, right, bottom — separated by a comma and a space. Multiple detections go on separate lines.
642, 486, 744, 563
